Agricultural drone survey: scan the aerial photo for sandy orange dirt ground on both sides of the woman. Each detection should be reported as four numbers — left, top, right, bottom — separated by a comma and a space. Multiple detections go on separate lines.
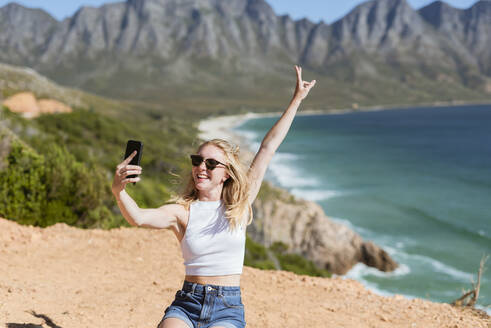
0, 219, 491, 328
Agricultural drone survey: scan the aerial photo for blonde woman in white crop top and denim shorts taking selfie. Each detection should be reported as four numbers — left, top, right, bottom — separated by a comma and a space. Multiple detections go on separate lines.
112, 66, 316, 328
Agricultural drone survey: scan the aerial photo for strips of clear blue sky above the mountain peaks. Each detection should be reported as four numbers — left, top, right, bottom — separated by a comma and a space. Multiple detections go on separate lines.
0, 0, 477, 23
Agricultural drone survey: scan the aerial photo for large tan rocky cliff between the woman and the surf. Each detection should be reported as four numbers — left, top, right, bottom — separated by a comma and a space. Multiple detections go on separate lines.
247, 182, 397, 274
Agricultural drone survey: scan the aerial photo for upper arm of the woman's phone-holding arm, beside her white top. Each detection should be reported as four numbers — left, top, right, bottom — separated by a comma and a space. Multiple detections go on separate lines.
139, 204, 184, 229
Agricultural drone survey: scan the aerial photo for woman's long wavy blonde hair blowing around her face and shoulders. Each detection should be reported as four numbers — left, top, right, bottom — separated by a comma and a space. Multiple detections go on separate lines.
171, 139, 253, 230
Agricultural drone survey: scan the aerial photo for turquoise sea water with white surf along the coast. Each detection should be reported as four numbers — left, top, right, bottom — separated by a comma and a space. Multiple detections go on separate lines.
236, 105, 491, 313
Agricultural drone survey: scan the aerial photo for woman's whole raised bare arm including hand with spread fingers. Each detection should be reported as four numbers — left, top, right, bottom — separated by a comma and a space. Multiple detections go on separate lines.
247, 65, 316, 204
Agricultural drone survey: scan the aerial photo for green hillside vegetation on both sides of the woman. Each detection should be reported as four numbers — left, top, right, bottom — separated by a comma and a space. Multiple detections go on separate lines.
0, 65, 330, 276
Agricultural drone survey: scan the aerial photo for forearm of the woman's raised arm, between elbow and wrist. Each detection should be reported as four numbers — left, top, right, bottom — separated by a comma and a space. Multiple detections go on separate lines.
261, 97, 302, 153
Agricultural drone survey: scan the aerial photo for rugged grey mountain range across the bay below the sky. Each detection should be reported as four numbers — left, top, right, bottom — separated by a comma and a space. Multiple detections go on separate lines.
0, 0, 491, 108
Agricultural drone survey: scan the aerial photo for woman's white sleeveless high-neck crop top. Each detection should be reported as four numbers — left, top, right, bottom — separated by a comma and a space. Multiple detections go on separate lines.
181, 200, 246, 276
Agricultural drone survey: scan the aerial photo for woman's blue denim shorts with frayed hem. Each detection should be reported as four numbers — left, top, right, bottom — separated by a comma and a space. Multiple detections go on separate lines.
159, 280, 246, 328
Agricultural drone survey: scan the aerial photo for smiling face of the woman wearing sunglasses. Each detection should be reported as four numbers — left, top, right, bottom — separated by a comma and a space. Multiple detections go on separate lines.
192, 144, 229, 191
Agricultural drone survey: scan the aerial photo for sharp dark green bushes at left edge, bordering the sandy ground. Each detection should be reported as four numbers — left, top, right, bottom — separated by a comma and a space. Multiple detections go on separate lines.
0, 132, 116, 227
